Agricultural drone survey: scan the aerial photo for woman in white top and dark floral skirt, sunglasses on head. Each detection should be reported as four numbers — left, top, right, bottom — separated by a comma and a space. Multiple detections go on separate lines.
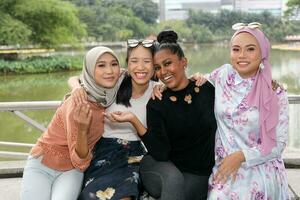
69, 40, 154, 200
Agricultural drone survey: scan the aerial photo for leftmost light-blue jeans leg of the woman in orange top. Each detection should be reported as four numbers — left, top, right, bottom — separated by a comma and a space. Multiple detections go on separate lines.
21, 157, 55, 200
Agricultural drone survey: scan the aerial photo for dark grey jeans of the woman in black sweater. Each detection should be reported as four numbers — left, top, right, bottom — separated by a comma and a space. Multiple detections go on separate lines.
140, 155, 209, 200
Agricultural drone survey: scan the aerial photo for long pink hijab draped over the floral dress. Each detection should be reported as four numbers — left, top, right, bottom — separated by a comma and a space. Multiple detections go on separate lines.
231, 27, 279, 155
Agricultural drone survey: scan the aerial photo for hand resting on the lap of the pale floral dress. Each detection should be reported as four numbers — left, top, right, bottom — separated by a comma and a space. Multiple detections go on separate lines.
213, 151, 245, 184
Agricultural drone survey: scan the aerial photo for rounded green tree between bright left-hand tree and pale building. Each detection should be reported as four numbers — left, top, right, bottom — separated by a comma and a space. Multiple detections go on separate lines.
71, 0, 158, 41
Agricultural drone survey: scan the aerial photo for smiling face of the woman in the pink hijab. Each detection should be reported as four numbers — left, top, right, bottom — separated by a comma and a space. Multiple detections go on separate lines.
230, 32, 262, 78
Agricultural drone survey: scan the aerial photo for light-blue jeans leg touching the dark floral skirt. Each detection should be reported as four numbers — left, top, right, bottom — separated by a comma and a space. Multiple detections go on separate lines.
51, 169, 83, 200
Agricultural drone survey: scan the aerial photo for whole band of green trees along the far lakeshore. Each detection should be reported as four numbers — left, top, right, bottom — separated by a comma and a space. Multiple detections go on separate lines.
0, 0, 300, 46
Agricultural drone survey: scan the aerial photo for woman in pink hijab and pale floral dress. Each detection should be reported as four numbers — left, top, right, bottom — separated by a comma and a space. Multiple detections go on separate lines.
206, 22, 289, 200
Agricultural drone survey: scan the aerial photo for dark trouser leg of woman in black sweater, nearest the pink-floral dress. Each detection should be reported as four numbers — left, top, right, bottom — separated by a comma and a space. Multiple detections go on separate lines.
183, 172, 209, 200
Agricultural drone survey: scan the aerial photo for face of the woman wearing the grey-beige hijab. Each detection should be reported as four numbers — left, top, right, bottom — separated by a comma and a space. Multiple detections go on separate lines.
94, 53, 120, 88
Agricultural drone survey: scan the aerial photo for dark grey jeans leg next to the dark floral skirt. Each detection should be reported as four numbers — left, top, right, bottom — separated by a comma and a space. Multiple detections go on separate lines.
140, 155, 185, 200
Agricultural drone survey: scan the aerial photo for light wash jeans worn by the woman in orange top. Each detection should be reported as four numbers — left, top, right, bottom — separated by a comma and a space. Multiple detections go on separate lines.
21, 156, 83, 200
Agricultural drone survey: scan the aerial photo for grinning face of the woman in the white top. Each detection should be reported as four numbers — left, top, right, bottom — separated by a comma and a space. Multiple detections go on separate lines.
127, 45, 154, 86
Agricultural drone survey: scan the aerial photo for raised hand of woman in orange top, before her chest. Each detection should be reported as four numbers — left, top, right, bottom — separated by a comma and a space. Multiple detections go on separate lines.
73, 104, 92, 134
